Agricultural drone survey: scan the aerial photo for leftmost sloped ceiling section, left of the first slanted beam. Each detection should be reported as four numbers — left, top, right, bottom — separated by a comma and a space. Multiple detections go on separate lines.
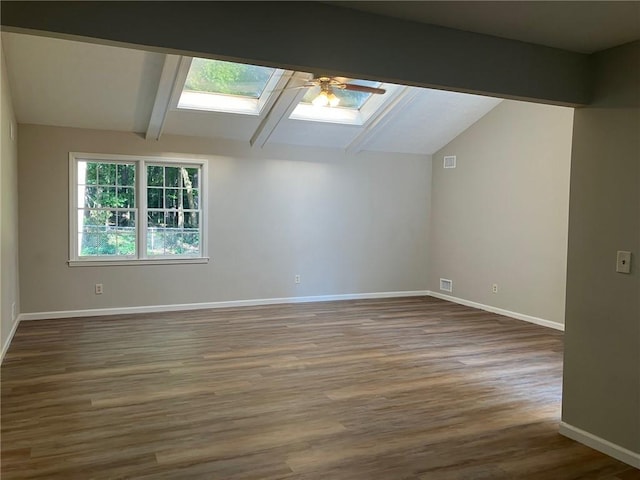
2, 33, 164, 132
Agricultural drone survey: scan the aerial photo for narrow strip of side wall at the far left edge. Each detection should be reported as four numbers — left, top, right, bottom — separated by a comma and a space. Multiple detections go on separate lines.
0, 40, 20, 353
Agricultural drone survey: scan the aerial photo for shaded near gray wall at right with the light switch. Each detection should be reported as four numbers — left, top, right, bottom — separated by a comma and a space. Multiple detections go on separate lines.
562, 42, 640, 453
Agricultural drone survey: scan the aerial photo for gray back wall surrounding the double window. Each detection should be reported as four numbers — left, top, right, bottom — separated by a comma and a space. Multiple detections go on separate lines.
19, 125, 431, 312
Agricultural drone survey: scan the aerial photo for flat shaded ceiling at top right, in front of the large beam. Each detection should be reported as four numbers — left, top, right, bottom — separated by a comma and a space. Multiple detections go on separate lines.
324, 0, 640, 53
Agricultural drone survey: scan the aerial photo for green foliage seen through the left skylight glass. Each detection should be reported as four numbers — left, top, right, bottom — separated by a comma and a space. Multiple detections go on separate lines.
184, 58, 274, 98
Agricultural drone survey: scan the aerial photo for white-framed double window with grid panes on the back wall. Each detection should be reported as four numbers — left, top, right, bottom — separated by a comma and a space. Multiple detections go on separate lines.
69, 153, 206, 265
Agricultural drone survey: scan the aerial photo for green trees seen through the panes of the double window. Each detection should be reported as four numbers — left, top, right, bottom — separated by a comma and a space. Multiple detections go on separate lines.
79, 162, 200, 256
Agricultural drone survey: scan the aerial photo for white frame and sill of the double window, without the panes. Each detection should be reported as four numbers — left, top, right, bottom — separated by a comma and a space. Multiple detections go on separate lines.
68, 152, 209, 267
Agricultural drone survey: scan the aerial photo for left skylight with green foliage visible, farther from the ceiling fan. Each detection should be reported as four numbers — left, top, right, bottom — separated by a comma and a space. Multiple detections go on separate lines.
178, 58, 283, 115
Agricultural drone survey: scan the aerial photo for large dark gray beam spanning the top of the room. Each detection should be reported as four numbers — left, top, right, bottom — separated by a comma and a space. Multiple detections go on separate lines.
0, 0, 592, 106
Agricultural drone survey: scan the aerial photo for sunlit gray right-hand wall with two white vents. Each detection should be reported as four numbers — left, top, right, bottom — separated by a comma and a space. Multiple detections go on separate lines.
429, 100, 573, 324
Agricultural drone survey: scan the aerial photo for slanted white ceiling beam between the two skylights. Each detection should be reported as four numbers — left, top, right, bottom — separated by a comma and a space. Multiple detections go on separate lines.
250, 72, 311, 148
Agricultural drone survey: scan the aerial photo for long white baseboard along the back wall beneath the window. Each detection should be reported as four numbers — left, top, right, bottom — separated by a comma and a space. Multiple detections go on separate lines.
20, 290, 429, 320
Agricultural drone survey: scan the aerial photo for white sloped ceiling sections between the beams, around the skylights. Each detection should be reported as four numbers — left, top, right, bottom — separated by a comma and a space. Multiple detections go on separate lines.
2, 32, 500, 154
